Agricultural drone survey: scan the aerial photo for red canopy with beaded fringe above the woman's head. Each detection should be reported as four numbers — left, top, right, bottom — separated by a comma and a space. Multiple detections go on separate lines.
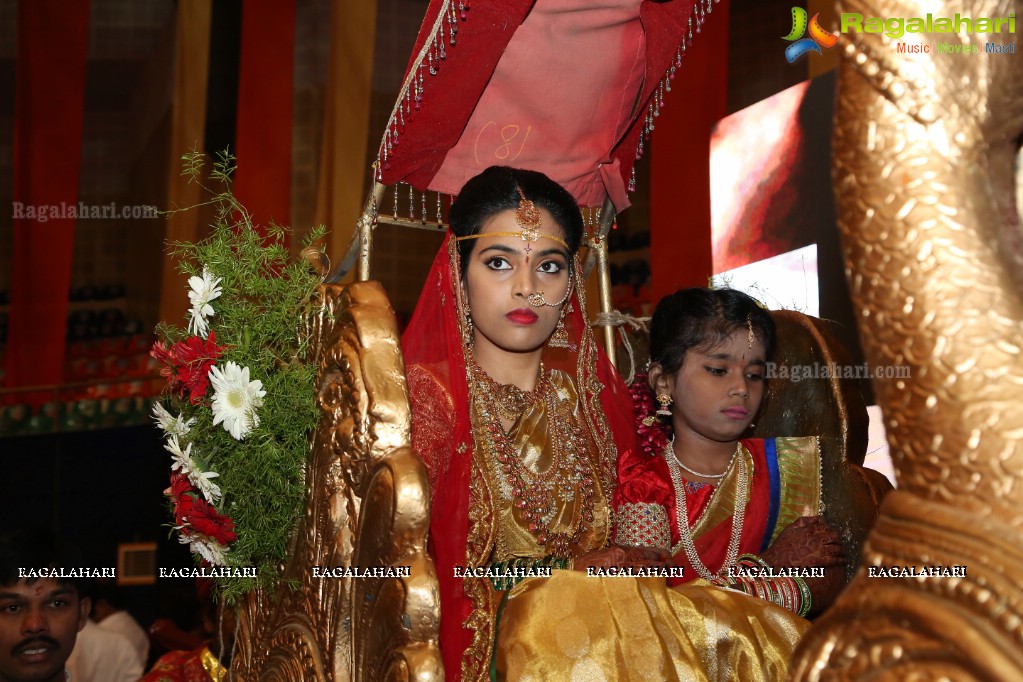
377, 0, 712, 211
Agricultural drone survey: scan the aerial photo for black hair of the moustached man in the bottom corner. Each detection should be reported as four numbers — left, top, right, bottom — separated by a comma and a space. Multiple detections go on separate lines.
0, 528, 86, 597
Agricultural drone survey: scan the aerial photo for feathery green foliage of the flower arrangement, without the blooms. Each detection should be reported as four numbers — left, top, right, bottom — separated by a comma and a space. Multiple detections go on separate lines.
158, 151, 324, 602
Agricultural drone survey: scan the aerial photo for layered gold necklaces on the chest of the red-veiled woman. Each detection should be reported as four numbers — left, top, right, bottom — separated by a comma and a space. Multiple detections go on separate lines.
466, 357, 594, 556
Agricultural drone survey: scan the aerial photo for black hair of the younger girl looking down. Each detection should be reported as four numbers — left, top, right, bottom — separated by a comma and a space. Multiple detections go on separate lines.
650, 287, 774, 374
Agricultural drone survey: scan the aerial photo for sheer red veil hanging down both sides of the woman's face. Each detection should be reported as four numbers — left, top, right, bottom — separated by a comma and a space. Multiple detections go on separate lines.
402, 233, 634, 680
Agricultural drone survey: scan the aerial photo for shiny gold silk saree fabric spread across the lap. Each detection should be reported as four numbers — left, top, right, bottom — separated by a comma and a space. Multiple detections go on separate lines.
495, 571, 810, 682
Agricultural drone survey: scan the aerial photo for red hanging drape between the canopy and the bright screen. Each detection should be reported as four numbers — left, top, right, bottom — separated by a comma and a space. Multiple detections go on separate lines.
650, 0, 728, 301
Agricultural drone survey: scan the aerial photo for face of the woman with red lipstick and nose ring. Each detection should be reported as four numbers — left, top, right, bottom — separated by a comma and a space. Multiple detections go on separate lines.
462, 209, 571, 354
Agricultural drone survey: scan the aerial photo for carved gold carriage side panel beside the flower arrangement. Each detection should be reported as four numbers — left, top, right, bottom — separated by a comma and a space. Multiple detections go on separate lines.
231, 282, 443, 682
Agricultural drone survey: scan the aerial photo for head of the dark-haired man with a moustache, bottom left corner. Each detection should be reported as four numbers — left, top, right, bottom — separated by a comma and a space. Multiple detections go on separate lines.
0, 530, 90, 682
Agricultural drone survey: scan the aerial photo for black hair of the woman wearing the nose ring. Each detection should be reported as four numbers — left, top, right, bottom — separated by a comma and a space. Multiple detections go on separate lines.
448, 166, 583, 276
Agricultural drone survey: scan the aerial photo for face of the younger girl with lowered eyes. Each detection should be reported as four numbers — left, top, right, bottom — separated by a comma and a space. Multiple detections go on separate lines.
651, 330, 766, 443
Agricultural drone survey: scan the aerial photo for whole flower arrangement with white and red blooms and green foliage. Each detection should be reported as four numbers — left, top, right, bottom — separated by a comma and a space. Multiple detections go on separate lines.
150, 152, 323, 602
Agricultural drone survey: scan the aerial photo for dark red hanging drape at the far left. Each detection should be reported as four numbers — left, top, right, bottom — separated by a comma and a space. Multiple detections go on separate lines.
7, 0, 90, 387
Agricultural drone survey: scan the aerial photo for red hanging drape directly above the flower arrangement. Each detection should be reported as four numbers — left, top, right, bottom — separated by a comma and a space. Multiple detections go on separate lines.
234, 0, 295, 239
